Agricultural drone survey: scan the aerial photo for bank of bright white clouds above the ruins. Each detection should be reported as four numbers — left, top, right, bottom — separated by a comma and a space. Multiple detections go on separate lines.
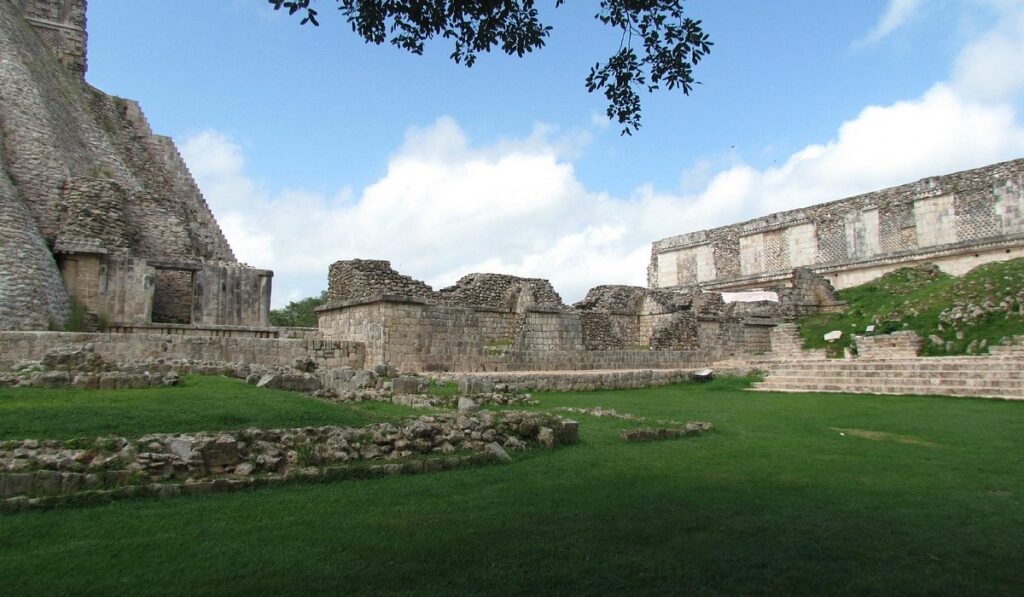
182, 0, 1024, 305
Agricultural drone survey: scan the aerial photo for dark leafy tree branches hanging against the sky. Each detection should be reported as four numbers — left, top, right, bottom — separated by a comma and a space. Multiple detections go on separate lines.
269, 0, 712, 134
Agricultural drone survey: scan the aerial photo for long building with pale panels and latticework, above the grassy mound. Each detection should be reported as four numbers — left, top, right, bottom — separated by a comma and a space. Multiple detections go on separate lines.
648, 160, 1024, 290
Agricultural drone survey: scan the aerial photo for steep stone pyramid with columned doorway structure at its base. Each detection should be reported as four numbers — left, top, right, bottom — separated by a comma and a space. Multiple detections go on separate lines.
0, 0, 272, 330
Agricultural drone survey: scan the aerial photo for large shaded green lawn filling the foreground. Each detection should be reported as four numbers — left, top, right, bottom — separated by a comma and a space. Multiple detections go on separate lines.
0, 380, 1024, 595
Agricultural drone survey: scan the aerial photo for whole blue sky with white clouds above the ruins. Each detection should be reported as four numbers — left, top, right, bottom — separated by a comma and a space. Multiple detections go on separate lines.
87, 0, 1024, 306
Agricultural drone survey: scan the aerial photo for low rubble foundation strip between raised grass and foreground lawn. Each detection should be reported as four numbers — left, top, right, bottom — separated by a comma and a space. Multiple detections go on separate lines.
0, 411, 579, 509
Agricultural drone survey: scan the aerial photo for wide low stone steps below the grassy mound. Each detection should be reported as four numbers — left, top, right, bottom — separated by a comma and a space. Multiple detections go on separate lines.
751, 354, 1024, 400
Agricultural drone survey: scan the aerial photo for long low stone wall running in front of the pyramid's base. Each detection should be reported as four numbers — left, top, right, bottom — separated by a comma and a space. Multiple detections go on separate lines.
0, 332, 366, 370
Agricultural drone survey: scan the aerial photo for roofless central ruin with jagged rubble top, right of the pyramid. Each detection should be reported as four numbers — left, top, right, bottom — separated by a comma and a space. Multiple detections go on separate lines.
317, 259, 830, 372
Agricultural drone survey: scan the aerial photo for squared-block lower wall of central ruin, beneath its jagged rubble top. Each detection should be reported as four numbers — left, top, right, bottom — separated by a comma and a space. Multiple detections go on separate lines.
317, 297, 773, 372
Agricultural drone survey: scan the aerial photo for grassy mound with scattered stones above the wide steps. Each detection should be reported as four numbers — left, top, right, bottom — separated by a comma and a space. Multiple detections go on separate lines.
800, 258, 1024, 356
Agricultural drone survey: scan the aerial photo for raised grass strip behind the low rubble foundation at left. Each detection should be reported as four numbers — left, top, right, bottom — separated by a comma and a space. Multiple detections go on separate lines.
0, 376, 415, 439
